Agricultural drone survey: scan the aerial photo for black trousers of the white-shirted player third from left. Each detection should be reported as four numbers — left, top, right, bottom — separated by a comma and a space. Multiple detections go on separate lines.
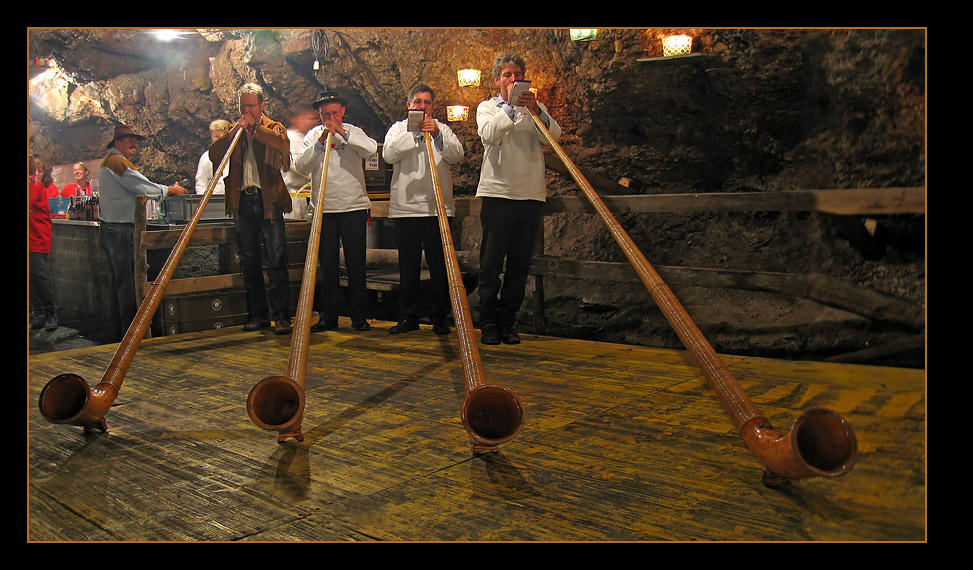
392, 216, 451, 323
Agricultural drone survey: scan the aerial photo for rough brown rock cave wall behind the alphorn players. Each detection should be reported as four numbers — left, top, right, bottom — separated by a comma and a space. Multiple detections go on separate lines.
28, 28, 926, 360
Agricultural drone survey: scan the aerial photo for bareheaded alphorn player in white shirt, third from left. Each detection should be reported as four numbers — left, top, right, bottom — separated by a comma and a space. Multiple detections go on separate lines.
382, 83, 463, 334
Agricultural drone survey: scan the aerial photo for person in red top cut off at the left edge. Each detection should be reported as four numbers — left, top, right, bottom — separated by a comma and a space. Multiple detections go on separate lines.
27, 157, 57, 331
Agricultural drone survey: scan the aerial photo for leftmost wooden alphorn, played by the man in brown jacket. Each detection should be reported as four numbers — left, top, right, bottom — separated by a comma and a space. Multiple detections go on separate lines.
38, 129, 243, 432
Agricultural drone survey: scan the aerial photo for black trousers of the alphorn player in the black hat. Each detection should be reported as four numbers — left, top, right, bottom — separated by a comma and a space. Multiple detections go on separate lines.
315, 210, 368, 324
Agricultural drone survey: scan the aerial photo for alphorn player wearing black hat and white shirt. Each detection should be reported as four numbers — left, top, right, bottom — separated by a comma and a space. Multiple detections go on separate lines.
294, 91, 378, 332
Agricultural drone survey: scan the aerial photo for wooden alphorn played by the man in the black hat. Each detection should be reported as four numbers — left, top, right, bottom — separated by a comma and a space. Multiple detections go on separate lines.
247, 132, 332, 443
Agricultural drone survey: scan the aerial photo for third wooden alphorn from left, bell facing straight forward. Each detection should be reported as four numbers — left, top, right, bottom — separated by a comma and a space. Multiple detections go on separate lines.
424, 133, 524, 453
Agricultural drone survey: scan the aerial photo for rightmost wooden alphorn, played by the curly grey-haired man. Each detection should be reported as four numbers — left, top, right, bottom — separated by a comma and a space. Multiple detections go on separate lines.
527, 109, 858, 485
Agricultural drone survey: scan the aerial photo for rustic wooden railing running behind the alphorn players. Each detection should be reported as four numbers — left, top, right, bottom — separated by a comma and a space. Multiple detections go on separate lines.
136, 184, 925, 346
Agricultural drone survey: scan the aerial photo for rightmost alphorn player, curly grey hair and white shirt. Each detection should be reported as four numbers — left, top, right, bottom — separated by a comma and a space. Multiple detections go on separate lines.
476, 53, 561, 344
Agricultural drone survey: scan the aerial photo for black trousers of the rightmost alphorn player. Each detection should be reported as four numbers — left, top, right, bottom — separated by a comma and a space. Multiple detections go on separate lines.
477, 198, 544, 328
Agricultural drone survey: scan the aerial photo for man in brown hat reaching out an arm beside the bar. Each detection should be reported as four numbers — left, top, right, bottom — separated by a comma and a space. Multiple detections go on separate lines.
98, 125, 186, 338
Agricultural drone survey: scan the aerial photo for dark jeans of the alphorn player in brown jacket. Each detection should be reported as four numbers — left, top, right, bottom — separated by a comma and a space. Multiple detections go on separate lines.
233, 192, 290, 320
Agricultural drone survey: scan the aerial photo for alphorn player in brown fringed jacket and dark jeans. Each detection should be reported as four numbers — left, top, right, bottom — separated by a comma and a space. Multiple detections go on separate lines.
209, 83, 291, 334
